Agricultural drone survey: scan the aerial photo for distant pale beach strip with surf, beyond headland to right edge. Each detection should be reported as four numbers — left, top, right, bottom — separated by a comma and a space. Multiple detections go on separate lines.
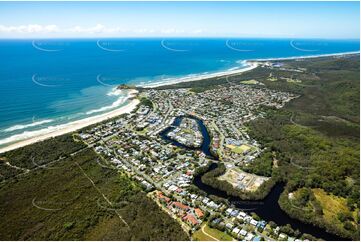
136, 51, 360, 89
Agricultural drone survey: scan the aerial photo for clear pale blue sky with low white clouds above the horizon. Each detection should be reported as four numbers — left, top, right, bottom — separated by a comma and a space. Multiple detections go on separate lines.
0, 2, 360, 39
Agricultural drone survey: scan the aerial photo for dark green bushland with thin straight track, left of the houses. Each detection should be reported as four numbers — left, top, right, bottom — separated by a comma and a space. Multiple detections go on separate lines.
0, 135, 188, 240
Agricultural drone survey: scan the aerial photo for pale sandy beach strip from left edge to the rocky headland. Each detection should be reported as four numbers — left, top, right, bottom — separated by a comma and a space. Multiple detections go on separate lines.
0, 90, 140, 154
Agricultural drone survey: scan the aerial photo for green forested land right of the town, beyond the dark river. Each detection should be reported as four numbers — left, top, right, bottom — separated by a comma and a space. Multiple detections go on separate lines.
246, 56, 360, 240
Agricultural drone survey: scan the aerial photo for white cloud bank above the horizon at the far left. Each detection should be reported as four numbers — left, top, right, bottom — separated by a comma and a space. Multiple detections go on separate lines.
0, 24, 59, 33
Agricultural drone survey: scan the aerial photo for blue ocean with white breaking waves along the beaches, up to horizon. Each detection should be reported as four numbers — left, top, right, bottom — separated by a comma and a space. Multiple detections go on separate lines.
0, 38, 360, 147
